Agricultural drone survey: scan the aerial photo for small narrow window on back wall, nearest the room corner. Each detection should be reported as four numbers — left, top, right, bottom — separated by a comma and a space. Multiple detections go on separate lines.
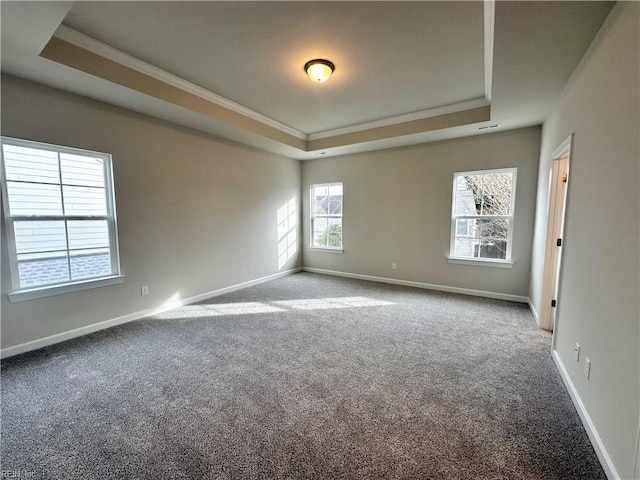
311, 183, 342, 250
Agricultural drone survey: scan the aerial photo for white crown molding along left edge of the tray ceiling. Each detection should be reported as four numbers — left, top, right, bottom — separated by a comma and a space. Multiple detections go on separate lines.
53, 24, 307, 140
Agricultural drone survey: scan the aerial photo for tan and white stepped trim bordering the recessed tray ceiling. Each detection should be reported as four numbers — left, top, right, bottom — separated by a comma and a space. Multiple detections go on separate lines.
40, 20, 495, 152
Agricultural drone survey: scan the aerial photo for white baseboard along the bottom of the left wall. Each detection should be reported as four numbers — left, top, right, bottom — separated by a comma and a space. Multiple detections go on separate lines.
0, 268, 302, 358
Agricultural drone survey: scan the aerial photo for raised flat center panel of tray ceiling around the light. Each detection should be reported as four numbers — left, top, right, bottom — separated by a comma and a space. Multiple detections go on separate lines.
64, 2, 484, 133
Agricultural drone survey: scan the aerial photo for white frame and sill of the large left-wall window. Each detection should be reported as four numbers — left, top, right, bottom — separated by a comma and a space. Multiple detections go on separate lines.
0, 137, 124, 303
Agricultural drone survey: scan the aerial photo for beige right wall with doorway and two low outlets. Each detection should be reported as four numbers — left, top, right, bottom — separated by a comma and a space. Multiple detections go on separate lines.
530, 2, 640, 479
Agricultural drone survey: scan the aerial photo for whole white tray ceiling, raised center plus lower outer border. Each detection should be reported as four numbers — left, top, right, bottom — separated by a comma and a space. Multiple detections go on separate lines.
0, 1, 612, 159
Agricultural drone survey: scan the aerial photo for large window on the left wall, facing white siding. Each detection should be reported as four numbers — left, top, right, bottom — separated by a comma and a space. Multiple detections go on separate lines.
2, 137, 121, 301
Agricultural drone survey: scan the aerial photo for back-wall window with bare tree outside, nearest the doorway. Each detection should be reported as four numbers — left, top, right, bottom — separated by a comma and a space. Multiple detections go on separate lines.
450, 168, 517, 263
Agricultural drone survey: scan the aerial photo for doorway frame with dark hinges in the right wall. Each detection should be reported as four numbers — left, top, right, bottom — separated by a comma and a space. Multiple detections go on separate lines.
540, 134, 573, 331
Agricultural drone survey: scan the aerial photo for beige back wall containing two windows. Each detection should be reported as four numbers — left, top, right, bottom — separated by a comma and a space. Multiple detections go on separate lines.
302, 127, 540, 297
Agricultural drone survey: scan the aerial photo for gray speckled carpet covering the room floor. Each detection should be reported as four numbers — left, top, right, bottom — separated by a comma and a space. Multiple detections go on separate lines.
1, 273, 605, 480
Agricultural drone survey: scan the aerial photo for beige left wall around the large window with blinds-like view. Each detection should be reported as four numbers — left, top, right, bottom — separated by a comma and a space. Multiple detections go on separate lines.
1, 76, 300, 348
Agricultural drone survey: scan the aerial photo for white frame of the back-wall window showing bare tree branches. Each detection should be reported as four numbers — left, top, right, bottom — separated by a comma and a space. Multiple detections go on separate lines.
448, 167, 518, 268
